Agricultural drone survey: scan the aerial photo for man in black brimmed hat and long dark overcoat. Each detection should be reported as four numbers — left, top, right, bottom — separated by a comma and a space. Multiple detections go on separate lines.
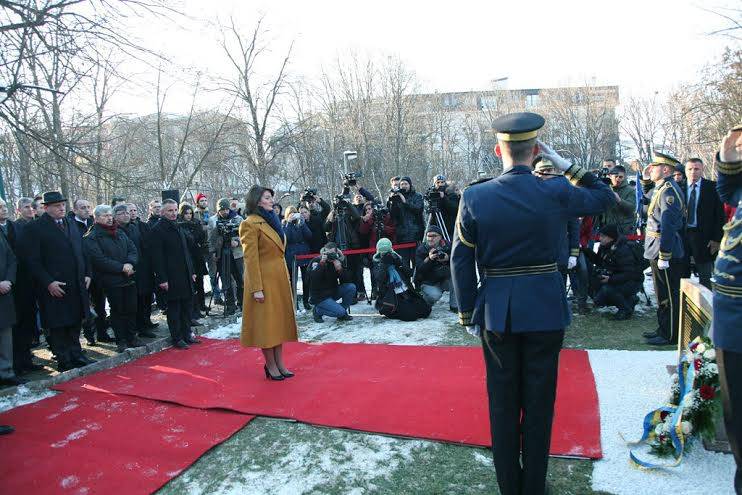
23, 191, 94, 371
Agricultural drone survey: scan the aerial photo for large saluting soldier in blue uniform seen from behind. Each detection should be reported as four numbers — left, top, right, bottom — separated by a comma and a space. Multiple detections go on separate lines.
451, 113, 616, 495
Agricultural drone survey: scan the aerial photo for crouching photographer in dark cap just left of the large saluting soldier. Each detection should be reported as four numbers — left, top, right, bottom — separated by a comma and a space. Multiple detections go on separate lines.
414, 225, 458, 313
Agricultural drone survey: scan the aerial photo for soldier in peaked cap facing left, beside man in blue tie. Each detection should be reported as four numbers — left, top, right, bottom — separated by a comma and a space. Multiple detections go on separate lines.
642, 153, 685, 345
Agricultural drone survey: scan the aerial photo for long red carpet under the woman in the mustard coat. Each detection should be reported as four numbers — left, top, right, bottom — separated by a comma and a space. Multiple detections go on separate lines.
56, 339, 601, 459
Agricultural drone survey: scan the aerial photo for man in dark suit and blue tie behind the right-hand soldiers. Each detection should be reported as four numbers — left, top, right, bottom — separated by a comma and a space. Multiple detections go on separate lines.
681, 158, 724, 290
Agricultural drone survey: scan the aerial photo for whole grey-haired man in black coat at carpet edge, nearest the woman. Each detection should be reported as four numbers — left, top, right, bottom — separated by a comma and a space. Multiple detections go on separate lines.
150, 199, 200, 349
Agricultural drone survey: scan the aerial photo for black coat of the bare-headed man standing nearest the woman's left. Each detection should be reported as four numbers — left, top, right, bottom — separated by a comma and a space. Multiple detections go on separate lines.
149, 218, 194, 300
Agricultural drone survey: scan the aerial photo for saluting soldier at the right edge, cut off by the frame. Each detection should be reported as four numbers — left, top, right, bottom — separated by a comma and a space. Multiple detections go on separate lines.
713, 125, 742, 495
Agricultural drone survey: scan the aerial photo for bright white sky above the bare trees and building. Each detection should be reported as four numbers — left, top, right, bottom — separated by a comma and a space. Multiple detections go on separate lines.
113, 0, 739, 113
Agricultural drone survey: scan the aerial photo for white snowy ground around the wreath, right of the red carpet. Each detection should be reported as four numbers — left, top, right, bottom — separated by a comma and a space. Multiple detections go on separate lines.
589, 350, 734, 495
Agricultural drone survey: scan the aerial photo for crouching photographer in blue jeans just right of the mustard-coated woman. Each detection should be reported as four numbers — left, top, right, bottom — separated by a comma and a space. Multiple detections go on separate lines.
309, 242, 356, 323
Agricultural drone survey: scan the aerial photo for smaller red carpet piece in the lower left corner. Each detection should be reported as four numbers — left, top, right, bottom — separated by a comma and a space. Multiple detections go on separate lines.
0, 392, 254, 495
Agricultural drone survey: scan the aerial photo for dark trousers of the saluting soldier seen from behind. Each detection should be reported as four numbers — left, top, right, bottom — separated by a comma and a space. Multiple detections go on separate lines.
482, 321, 564, 495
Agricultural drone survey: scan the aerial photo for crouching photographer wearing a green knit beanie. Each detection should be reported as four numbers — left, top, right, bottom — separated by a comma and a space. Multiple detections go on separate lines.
371, 237, 431, 321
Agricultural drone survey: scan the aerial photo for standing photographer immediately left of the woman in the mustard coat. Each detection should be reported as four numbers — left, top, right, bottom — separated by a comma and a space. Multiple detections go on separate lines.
208, 198, 244, 316
